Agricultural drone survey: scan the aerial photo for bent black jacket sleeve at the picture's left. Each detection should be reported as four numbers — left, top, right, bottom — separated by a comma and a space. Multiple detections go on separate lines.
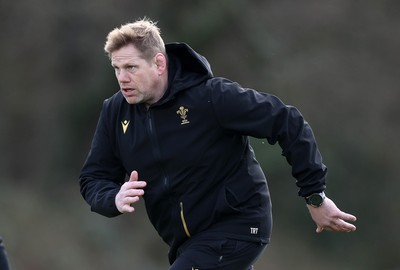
79, 101, 125, 217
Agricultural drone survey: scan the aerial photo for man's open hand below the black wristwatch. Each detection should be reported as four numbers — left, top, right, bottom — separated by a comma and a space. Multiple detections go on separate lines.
307, 197, 357, 233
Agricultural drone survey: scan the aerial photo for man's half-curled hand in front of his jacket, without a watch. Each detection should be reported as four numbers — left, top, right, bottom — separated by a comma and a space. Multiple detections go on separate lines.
115, 171, 147, 213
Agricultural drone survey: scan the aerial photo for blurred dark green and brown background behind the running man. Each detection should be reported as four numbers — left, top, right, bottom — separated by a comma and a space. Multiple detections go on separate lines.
0, 0, 400, 270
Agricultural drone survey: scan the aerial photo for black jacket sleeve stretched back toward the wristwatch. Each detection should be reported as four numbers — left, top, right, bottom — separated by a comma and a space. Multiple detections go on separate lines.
211, 79, 327, 197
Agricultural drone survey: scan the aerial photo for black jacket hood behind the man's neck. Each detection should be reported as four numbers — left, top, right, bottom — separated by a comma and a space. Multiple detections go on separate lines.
165, 43, 213, 99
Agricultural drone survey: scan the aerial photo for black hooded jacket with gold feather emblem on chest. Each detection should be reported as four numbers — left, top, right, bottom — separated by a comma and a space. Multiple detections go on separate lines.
80, 43, 326, 261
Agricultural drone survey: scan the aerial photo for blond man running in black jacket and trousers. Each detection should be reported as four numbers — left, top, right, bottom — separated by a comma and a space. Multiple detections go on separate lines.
80, 19, 356, 270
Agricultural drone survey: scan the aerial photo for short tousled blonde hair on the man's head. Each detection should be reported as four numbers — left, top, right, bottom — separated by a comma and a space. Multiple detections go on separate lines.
104, 18, 165, 60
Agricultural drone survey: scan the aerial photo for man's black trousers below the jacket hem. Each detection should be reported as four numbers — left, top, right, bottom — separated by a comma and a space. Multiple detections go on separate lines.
169, 233, 266, 270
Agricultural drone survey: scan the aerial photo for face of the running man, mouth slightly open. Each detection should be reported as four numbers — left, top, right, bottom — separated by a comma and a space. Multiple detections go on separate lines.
111, 44, 166, 106
